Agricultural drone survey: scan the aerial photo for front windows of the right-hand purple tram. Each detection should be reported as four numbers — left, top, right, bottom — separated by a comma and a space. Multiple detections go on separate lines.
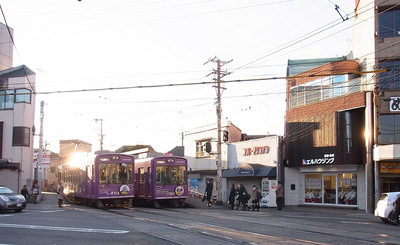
156, 166, 186, 185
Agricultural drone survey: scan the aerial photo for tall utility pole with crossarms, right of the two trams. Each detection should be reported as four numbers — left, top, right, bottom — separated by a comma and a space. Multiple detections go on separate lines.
204, 57, 232, 205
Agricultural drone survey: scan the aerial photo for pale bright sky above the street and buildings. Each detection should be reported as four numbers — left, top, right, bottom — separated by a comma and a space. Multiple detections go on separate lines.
0, 0, 354, 152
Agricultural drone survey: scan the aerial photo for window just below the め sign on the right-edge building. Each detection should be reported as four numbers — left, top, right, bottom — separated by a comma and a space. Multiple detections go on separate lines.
378, 114, 400, 144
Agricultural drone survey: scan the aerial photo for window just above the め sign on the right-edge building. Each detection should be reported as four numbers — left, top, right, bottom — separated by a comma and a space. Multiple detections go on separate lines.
379, 60, 400, 90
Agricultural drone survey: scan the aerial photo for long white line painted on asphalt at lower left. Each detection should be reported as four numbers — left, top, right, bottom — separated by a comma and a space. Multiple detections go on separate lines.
0, 223, 129, 234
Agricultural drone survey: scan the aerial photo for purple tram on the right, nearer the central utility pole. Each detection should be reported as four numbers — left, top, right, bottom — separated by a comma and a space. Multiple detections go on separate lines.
134, 156, 189, 208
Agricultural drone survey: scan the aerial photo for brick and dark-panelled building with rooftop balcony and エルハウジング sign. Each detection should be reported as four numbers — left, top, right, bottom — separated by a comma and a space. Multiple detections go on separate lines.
284, 57, 366, 209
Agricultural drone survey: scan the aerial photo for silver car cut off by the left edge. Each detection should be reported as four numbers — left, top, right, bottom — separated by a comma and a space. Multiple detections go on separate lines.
0, 186, 26, 212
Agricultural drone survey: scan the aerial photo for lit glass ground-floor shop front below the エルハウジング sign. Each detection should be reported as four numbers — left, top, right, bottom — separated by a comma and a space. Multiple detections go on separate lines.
285, 165, 365, 208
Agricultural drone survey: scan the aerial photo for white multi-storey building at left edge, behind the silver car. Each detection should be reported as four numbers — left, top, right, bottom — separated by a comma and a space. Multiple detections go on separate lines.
0, 21, 36, 192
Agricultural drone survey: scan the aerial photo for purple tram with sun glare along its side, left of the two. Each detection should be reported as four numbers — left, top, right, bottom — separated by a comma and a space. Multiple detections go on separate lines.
58, 153, 134, 208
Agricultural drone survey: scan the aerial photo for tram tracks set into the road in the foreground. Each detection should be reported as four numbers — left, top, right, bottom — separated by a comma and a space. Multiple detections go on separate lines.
72, 205, 400, 244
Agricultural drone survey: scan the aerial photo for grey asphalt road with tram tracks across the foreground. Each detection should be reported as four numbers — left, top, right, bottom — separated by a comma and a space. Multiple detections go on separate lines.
0, 193, 400, 245
